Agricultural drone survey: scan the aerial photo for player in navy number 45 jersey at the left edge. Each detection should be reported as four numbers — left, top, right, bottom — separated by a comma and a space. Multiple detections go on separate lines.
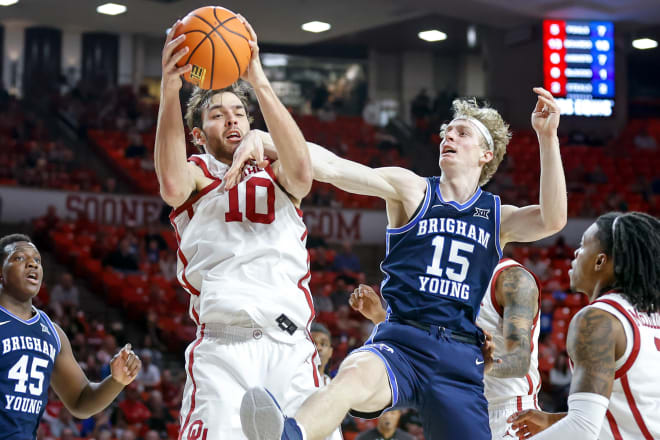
0, 234, 142, 440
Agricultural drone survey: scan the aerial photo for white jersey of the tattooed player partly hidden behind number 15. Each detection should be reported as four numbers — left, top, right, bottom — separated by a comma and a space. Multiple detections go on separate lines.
477, 258, 541, 405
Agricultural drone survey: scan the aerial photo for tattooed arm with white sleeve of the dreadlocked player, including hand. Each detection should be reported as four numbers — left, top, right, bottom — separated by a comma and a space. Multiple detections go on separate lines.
510, 307, 625, 440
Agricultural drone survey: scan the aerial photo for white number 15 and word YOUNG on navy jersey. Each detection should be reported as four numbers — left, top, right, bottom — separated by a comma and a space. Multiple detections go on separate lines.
419, 239, 474, 300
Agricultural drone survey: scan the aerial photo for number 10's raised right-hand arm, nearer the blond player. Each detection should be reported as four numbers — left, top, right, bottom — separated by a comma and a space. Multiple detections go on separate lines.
238, 15, 312, 200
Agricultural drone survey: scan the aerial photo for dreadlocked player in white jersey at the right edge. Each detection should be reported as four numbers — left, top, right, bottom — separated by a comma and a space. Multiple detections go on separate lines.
510, 212, 660, 440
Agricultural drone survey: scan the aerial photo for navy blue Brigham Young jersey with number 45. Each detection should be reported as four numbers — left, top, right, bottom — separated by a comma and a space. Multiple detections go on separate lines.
0, 307, 61, 440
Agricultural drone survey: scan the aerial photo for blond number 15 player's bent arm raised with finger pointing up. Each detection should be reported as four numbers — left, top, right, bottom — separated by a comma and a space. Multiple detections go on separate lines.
501, 87, 568, 247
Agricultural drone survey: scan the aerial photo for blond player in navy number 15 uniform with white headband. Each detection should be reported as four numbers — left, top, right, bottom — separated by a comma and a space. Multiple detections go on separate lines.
232, 88, 567, 440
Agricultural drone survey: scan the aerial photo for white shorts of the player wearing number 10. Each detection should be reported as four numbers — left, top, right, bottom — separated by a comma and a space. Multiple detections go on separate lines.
179, 324, 321, 440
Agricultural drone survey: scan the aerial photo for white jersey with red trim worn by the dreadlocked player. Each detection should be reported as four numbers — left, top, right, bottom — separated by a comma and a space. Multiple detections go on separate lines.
588, 293, 660, 440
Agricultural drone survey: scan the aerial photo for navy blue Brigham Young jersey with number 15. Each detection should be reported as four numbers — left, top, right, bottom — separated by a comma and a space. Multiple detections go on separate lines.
381, 177, 502, 333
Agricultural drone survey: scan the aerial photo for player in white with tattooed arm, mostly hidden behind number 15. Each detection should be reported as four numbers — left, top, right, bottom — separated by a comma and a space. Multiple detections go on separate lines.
349, 258, 541, 440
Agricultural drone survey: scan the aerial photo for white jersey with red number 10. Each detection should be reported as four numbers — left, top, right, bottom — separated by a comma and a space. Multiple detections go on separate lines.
170, 154, 314, 342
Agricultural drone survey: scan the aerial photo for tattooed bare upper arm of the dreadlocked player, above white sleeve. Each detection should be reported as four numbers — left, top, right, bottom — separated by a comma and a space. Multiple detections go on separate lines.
566, 307, 623, 399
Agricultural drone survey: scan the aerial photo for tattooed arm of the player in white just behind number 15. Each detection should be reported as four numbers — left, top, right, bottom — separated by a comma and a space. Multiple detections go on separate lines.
488, 266, 539, 378
